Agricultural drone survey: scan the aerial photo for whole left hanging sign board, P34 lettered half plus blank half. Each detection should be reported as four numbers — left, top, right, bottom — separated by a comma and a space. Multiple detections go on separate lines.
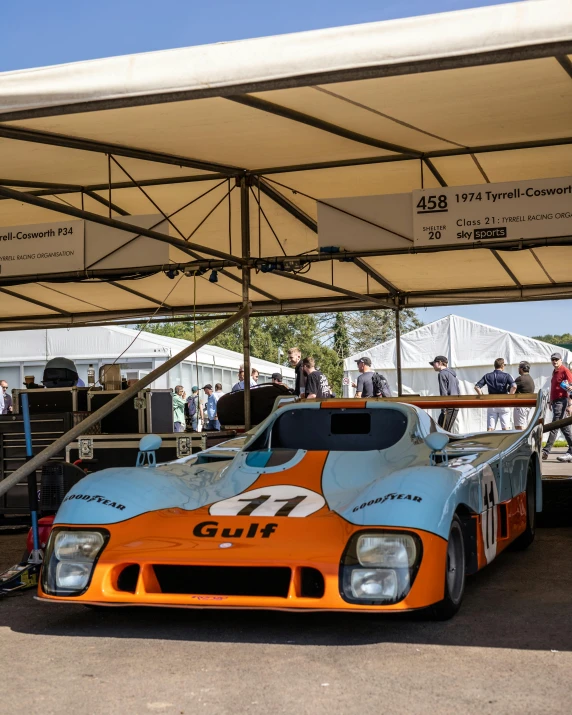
0, 215, 169, 276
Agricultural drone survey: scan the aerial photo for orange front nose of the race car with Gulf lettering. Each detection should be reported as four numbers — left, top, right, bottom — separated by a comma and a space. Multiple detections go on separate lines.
38, 509, 447, 611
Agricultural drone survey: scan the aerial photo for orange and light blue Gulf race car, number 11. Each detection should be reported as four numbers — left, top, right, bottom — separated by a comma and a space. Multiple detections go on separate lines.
39, 393, 546, 619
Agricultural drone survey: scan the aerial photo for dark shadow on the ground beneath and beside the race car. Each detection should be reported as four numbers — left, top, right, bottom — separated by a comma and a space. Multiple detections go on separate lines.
0, 528, 572, 651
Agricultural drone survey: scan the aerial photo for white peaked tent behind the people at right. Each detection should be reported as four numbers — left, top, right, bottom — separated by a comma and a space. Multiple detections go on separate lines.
344, 315, 572, 432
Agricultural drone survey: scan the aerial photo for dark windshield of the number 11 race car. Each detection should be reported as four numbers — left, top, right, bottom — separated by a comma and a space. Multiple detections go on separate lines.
247, 408, 407, 452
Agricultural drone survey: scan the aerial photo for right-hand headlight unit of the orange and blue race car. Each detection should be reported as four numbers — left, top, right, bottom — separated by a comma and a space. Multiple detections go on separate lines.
340, 531, 422, 605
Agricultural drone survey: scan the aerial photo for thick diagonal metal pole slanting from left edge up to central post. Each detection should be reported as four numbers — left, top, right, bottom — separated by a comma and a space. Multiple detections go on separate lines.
0, 303, 250, 496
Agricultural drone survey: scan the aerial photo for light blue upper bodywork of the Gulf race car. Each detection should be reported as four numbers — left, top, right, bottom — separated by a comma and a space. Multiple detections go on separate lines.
55, 401, 542, 539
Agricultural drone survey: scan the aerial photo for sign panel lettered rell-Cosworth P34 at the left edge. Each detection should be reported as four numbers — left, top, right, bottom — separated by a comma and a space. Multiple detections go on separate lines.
0, 221, 85, 276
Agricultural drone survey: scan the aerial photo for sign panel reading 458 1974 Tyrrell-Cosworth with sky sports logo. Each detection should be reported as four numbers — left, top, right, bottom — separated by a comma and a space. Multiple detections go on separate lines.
413, 177, 572, 246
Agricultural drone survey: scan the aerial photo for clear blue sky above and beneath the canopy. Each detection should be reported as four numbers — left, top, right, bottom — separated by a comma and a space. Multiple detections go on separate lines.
0, 0, 572, 335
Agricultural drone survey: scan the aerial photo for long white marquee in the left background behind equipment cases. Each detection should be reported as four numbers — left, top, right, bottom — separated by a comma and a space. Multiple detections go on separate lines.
0, 326, 294, 392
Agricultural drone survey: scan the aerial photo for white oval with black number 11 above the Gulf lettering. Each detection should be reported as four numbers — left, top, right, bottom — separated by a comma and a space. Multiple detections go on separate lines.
209, 484, 326, 517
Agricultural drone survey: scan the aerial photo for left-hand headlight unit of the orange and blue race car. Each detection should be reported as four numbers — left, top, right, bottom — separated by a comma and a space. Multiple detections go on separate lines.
41, 527, 109, 596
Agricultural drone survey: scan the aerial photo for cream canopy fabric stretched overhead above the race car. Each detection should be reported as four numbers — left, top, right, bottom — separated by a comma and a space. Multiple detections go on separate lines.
0, 0, 572, 330
